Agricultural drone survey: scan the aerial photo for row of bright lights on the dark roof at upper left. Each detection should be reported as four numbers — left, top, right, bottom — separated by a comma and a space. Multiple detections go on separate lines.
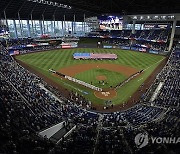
27, 0, 72, 9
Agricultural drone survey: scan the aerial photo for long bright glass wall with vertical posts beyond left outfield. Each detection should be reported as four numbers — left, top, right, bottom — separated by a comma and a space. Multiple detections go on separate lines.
8, 20, 94, 37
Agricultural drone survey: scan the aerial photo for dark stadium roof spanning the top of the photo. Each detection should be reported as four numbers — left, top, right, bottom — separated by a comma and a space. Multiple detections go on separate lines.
0, 0, 180, 21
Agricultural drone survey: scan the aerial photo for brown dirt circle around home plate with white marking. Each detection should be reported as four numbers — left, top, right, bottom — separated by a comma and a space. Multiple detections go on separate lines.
94, 89, 117, 100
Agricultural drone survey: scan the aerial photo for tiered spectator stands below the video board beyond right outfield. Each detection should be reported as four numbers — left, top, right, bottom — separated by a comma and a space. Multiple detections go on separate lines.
88, 29, 169, 53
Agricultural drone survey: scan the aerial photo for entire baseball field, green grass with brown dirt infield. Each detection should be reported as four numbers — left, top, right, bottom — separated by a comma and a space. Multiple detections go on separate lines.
16, 48, 165, 110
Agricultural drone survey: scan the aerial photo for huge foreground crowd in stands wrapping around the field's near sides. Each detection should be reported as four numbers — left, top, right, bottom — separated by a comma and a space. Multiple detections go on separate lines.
0, 37, 180, 154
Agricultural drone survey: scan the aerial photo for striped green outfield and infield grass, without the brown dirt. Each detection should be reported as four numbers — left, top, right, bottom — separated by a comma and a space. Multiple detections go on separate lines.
16, 49, 164, 104
